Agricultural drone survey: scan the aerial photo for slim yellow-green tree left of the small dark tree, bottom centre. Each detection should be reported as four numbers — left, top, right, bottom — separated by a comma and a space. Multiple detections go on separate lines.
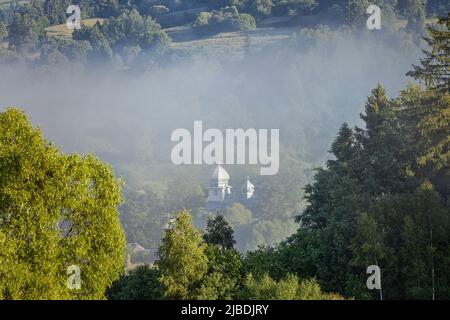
156, 211, 208, 299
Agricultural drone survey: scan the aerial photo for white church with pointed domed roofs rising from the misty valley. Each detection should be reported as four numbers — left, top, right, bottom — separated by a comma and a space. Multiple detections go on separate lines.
206, 164, 255, 211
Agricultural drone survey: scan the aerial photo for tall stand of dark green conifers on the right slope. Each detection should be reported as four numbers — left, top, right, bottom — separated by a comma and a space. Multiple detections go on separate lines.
236, 18, 450, 299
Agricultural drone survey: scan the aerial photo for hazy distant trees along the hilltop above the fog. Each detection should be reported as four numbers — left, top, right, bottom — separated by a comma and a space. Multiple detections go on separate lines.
0, 0, 449, 67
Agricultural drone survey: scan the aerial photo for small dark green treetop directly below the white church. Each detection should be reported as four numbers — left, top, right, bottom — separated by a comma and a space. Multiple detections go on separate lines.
204, 215, 236, 249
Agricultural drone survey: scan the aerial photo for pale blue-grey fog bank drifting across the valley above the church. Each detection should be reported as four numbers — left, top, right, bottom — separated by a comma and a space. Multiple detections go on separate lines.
0, 31, 420, 186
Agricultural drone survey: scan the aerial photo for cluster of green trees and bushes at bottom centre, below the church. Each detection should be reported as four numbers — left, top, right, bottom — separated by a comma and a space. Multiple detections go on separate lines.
107, 211, 340, 300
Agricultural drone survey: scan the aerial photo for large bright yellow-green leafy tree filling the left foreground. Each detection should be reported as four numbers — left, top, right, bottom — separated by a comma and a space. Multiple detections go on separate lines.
0, 109, 125, 299
